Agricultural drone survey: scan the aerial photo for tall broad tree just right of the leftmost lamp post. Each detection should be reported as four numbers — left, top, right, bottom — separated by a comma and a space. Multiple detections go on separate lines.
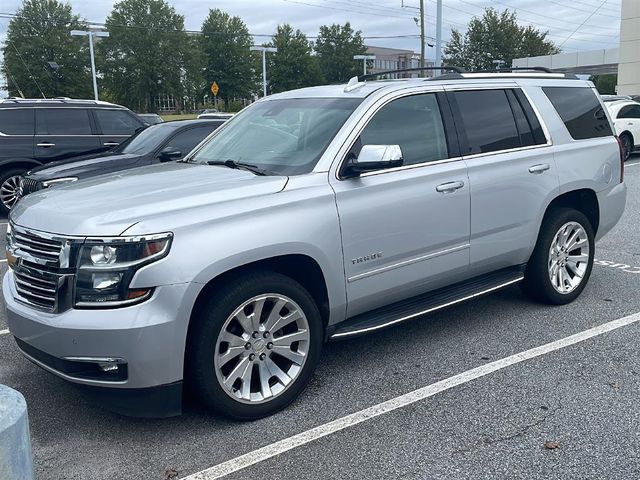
98, 0, 190, 112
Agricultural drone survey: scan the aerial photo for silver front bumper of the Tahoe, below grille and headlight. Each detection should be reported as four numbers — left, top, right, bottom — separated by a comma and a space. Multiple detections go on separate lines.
2, 270, 193, 413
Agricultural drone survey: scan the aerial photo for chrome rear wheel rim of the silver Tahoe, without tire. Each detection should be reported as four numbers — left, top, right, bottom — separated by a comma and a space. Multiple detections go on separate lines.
548, 222, 590, 294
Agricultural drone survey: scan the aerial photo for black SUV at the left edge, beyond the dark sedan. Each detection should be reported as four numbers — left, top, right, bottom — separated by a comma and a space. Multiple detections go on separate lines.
0, 98, 146, 213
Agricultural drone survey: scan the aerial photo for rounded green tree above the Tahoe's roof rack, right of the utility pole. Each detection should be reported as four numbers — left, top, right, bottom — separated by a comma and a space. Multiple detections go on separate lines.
443, 8, 560, 70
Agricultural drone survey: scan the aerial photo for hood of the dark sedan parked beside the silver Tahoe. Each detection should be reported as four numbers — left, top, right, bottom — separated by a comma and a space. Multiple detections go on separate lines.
28, 154, 141, 181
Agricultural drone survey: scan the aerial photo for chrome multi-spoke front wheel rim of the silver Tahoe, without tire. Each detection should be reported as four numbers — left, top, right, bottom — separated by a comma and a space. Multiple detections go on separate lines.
214, 293, 310, 404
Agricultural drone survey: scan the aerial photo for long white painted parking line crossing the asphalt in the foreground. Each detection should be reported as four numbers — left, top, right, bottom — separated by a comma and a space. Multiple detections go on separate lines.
183, 312, 640, 480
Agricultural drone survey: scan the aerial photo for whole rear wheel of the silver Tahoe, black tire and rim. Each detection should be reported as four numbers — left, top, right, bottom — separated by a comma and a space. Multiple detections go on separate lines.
521, 208, 595, 305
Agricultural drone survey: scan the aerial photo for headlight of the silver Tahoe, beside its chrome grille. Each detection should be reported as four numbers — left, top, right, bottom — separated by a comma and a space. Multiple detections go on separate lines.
75, 233, 173, 308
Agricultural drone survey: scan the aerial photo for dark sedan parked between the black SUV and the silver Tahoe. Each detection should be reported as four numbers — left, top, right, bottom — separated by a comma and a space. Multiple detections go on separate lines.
20, 120, 224, 196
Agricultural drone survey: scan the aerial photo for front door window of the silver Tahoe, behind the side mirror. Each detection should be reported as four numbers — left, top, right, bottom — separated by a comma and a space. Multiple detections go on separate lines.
360, 94, 448, 165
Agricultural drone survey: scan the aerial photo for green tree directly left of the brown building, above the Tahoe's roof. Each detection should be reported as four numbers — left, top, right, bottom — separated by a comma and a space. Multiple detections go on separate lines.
315, 22, 367, 83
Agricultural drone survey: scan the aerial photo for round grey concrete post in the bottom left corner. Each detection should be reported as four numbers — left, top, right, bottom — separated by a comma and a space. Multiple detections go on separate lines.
0, 385, 34, 480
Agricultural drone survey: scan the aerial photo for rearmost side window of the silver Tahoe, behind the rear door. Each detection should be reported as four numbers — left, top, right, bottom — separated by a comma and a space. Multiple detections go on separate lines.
542, 87, 613, 140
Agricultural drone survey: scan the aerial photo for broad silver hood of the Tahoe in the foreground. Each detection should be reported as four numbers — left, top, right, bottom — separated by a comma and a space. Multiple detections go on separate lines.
10, 162, 288, 236
